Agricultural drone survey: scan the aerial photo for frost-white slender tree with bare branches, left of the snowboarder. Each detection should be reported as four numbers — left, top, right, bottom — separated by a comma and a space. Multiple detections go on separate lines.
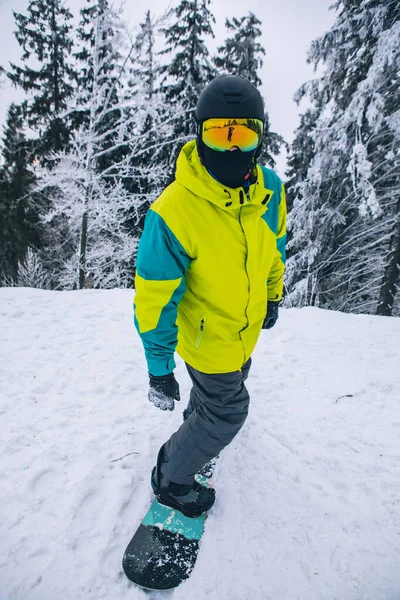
38, 2, 162, 288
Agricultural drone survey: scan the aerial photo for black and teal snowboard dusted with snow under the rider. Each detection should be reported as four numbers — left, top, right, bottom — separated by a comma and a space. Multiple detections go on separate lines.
122, 475, 209, 590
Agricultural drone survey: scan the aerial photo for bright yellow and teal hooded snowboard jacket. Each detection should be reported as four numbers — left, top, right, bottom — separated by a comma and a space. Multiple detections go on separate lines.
134, 141, 286, 375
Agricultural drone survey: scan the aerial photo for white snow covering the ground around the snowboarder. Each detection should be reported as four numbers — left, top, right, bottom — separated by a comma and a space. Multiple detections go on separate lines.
0, 288, 400, 600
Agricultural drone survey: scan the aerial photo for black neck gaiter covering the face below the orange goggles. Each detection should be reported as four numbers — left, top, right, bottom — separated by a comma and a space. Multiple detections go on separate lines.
199, 142, 256, 188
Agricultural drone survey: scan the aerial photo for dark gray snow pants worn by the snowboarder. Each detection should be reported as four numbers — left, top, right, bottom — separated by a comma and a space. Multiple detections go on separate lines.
160, 358, 251, 484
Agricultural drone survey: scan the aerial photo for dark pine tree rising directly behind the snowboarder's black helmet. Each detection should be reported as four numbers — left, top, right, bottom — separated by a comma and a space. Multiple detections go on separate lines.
213, 12, 284, 167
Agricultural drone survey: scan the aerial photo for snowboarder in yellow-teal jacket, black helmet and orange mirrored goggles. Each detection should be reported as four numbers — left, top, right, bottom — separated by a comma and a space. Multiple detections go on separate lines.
135, 75, 286, 517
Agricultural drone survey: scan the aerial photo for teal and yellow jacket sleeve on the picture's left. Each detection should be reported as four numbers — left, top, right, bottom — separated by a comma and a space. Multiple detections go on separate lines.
134, 208, 191, 375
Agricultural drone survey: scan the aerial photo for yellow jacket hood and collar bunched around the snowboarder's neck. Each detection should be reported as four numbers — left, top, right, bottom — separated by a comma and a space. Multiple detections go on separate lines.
175, 140, 274, 213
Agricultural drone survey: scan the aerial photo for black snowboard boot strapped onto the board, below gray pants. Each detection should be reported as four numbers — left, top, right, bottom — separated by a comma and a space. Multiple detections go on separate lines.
151, 450, 215, 518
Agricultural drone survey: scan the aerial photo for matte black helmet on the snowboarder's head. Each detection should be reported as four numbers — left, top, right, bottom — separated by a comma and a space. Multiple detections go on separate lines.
195, 75, 264, 122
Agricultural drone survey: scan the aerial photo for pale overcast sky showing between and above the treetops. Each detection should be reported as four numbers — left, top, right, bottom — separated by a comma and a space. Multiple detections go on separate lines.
0, 0, 335, 175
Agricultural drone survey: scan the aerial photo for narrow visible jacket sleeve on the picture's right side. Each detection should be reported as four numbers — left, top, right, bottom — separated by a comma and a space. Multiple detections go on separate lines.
267, 184, 286, 302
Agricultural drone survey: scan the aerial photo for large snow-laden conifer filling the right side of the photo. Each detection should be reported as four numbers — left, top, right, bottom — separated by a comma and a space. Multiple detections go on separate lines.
286, 0, 400, 314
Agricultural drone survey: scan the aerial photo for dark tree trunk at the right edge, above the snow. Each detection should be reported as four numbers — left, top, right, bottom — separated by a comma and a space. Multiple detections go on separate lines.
376, 209, 400, 317
